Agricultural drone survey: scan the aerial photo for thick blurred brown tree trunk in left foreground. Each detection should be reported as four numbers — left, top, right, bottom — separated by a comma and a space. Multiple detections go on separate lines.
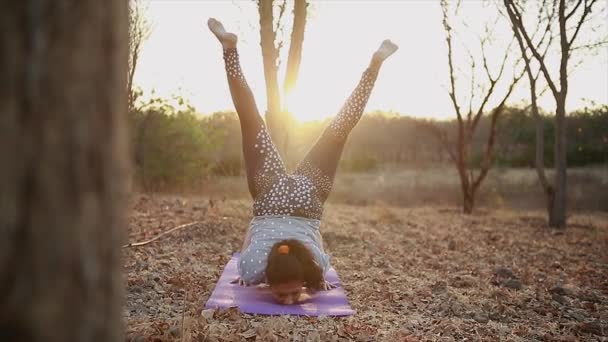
0, 0, 128, 342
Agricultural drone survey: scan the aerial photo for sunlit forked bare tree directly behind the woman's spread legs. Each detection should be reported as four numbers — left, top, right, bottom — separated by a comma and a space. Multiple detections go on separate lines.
258, 0, 308, 157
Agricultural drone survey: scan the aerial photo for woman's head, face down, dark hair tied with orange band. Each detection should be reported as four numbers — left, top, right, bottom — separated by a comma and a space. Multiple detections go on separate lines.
266, 240, 323, 304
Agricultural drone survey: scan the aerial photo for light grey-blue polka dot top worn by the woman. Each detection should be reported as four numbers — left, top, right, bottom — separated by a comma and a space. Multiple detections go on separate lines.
238, 216, 330, 284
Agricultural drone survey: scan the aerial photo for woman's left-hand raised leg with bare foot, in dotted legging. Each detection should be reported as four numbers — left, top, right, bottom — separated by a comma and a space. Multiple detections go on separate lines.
208, 19, 286, 199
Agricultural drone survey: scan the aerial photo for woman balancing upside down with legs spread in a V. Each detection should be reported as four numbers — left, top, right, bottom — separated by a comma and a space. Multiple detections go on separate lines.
208, 18, 397, 304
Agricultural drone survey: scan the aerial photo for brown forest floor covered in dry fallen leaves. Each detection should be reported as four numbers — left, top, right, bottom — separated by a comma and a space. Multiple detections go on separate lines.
124, 195, 608, 342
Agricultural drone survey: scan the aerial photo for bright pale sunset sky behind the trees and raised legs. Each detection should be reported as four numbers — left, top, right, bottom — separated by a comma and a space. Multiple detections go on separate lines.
135, 0, 608, 121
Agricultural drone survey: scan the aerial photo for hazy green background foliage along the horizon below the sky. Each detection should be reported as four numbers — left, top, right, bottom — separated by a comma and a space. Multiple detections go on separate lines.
130, 94, 608, 191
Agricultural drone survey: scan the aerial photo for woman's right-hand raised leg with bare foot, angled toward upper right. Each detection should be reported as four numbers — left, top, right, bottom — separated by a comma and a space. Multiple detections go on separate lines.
295, 40, 397, 202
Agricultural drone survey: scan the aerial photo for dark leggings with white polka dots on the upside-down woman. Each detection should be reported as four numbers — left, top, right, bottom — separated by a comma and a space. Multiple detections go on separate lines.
224, 49, 378, 219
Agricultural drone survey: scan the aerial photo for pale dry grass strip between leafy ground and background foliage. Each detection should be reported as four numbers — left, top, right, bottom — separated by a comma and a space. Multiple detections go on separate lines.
190, 166, 608, 211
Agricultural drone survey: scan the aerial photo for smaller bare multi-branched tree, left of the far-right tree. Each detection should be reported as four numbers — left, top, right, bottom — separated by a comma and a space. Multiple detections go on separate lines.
430, 0, 524, 214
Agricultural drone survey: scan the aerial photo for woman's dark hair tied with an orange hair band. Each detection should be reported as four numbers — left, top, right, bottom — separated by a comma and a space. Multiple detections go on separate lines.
266, 239, 323, 290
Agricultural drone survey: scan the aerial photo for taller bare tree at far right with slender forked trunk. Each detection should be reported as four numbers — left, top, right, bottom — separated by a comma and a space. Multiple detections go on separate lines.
503, 0, 605, 228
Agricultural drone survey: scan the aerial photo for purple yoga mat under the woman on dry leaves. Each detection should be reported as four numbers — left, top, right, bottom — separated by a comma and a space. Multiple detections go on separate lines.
205, 253, 355, 316
